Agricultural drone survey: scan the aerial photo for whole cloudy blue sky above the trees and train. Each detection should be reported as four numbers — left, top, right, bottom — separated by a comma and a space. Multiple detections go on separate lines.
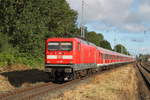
66, 0, 150, 55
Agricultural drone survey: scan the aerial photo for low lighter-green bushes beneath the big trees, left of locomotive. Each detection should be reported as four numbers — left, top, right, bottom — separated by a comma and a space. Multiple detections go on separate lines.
0, 52, 44, 68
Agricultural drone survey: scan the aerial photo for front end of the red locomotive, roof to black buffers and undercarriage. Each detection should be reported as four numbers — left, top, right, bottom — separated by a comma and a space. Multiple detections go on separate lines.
45, 38, 74, 81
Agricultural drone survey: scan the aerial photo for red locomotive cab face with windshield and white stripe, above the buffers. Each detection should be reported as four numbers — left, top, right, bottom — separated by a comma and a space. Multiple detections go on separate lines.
46, 42, 73, 64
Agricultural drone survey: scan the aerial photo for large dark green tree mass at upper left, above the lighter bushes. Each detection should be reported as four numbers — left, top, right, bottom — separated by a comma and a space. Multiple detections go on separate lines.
0, 0, 77, 55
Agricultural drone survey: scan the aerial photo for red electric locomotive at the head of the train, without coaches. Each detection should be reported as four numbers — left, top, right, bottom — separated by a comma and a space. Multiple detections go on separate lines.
45, 38, 97, 80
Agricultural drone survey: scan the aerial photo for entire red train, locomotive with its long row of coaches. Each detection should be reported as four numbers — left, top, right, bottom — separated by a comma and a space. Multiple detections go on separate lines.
45, 38, 134, 81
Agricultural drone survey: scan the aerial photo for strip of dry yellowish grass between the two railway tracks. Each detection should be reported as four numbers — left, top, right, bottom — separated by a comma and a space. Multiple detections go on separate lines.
51, 64, 138, 100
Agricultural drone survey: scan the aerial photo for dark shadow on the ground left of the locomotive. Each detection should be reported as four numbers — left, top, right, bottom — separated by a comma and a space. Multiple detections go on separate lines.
0, 69, 49, 87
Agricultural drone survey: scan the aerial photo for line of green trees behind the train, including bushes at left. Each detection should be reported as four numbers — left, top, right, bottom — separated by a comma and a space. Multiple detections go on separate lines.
0, 0, 129, 66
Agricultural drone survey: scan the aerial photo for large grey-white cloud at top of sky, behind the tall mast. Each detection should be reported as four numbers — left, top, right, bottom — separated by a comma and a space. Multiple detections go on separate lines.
67, 0, 132, 23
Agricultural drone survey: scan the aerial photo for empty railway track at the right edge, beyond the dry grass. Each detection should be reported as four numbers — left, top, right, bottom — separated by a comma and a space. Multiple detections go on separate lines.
136, 62, 150, 100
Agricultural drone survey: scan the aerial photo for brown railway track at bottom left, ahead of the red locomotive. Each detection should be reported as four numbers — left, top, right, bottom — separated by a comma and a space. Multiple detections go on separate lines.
0, 80, 78, 100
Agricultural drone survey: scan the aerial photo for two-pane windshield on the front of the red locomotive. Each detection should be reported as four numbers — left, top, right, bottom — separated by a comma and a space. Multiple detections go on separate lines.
48, 42, 72, 51
